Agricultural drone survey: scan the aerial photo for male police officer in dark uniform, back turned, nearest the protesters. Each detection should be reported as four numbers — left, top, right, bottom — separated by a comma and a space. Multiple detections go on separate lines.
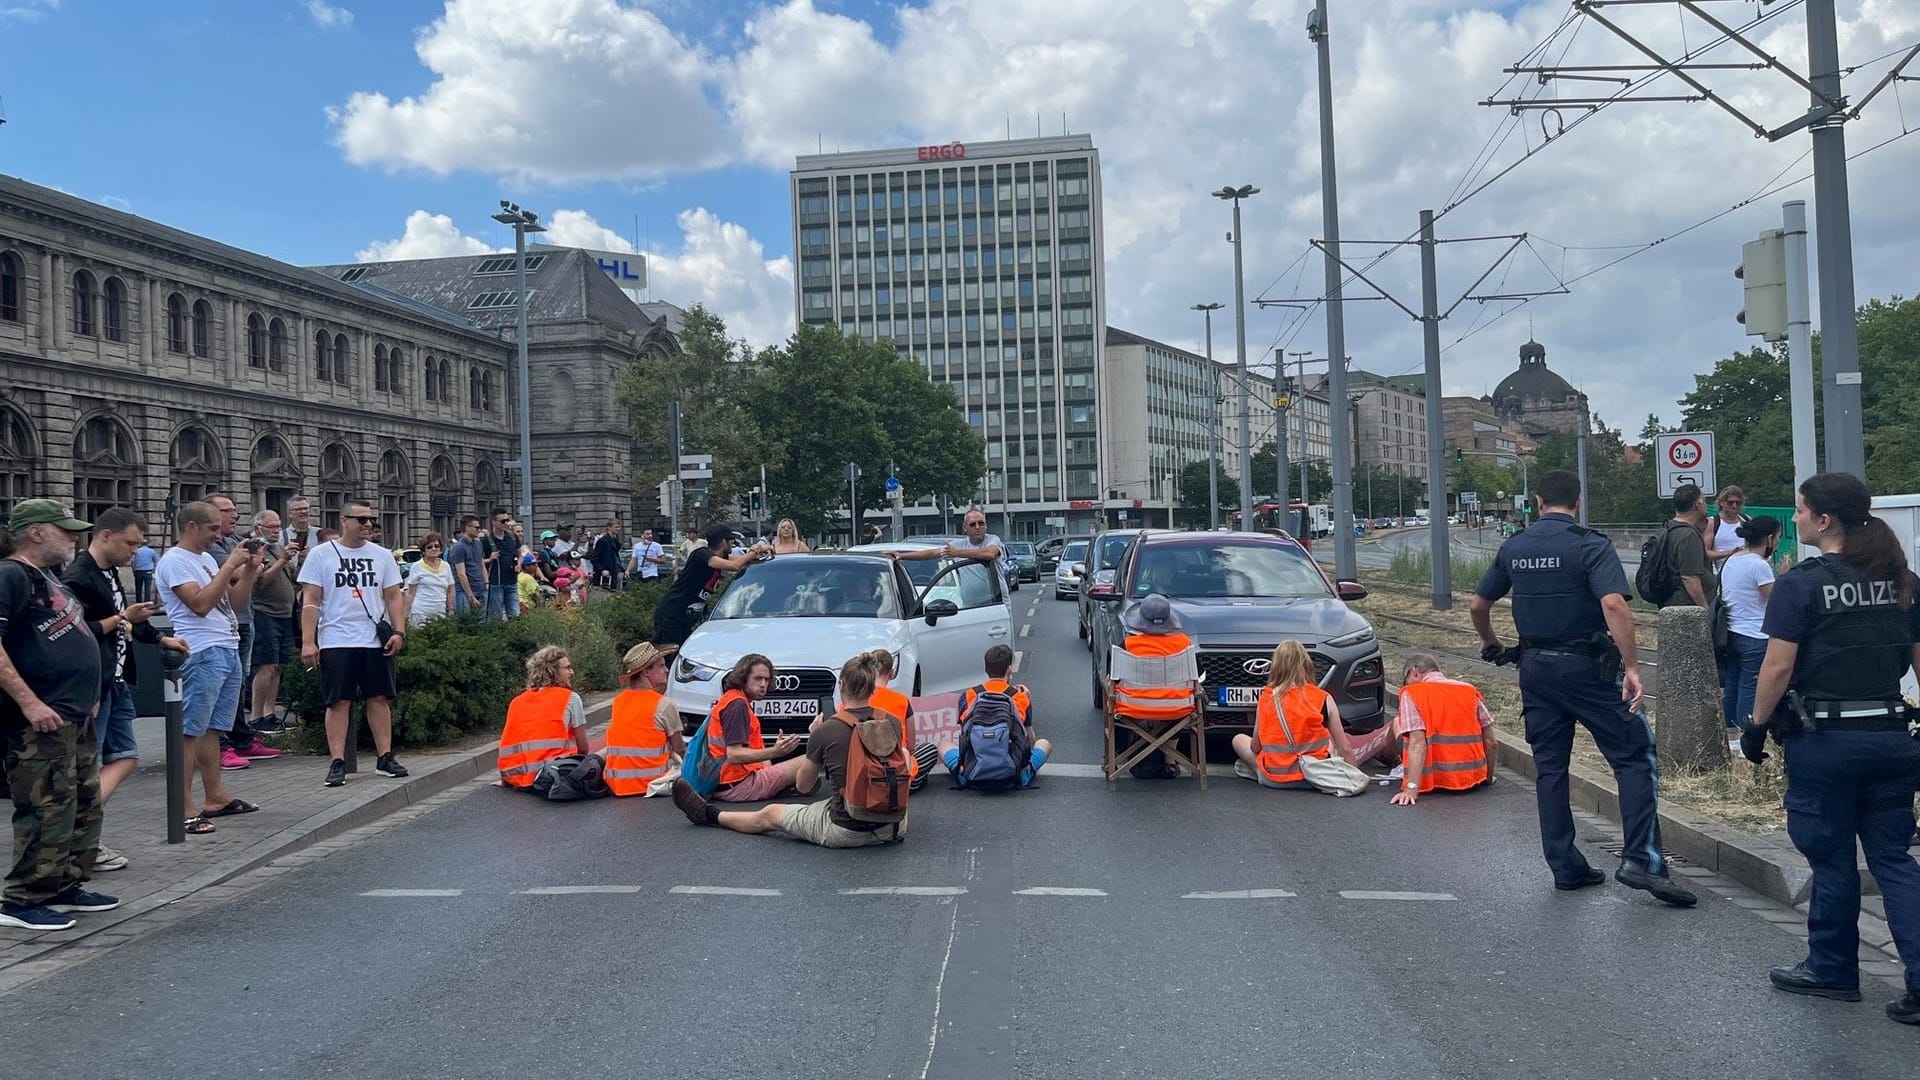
1471, 469, 1695, 907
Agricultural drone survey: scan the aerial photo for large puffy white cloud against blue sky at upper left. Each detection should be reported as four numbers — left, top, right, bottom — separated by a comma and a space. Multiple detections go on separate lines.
328, 0, 728, 181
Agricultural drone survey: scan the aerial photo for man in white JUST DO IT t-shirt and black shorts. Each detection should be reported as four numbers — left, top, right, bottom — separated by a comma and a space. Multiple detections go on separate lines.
300, 502, 407, 788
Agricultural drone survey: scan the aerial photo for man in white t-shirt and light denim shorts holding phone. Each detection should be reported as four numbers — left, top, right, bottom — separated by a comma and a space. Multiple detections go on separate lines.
154, 502, 265, 832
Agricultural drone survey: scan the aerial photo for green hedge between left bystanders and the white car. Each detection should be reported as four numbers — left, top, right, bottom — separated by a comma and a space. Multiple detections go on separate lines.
284, 584, 664, 753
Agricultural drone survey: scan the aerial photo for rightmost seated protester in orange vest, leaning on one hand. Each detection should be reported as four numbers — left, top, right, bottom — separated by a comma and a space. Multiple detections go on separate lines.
1392, 653, 1500, 807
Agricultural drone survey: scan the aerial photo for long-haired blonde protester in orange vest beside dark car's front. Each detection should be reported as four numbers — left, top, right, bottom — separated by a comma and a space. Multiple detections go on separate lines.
1233, 642, 1390, 790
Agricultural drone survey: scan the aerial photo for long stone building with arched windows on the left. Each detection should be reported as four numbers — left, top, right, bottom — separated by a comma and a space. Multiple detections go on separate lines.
0, 177, 511, 546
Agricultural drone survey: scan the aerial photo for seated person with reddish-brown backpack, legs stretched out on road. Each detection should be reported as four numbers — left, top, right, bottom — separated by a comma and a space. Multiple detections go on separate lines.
674, 655, 906, 847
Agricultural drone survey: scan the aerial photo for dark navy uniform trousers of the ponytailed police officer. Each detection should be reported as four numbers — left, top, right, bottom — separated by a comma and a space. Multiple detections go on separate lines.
1786, 730, 1920, 992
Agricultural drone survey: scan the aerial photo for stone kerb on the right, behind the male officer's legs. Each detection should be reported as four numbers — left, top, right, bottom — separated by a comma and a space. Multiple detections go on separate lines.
1494, 728, 1812, 907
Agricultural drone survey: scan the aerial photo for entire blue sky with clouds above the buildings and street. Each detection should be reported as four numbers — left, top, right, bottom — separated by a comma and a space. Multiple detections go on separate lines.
0, 0, 1920, 430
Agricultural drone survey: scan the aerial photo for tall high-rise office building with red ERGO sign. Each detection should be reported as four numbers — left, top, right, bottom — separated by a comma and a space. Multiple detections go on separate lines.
793, 135, 1105, 538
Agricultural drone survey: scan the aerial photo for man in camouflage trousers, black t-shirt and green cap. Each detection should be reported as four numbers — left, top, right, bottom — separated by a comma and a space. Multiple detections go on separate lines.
0, 500, 119, 930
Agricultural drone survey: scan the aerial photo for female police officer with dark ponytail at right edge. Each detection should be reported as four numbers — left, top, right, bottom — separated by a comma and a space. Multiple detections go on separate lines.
1740, 473, 1920, 1024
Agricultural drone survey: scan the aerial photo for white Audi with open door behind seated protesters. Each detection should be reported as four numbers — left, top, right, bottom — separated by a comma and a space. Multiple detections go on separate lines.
668, 542, 1014, 732
